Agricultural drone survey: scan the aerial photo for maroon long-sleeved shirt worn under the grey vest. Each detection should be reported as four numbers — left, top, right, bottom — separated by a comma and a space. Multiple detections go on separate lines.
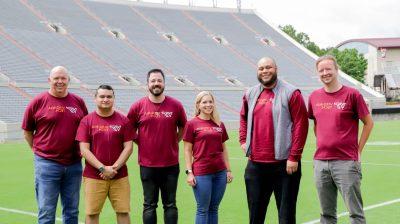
239, 89, 308, 163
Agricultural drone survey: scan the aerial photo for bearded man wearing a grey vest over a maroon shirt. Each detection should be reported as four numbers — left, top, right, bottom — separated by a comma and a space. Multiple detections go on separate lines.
239, 57, 308, 224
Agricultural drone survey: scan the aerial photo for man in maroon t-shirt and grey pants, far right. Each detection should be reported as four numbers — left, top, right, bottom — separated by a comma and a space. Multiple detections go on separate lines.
308, 55, 373, 223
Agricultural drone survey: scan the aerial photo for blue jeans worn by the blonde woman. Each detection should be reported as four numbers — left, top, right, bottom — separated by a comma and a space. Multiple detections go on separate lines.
193, 170, 226, 224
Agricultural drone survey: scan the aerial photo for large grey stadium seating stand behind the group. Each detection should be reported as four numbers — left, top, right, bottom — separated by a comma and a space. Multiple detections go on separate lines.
0, 0, 384, 140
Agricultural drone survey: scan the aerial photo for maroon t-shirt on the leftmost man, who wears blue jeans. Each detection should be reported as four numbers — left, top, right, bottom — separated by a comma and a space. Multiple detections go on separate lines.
22, 92, 88, 165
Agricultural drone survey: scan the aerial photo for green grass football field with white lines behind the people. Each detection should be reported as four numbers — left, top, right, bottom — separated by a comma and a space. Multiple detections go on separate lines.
0, 121, 400, 224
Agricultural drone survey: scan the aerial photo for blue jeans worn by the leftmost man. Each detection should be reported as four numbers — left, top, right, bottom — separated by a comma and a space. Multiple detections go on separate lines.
35, 155, 82, 224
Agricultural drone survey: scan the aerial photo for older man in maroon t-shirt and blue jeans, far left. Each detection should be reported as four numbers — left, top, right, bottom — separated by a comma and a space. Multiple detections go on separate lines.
22, 66, 88, 224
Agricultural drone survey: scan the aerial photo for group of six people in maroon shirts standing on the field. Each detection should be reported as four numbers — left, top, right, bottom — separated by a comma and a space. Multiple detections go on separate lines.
22, 55, 373, 224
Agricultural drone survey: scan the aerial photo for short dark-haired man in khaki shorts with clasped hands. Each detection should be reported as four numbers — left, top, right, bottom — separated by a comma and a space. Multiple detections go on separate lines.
76, 85, 135, 224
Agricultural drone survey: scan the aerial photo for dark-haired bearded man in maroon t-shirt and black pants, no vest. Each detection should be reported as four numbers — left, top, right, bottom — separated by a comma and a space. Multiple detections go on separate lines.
128, 69, 186, 224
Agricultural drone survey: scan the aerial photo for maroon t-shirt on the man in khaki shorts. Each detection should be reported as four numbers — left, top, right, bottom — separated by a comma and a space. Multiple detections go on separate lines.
76, 111, 135, 179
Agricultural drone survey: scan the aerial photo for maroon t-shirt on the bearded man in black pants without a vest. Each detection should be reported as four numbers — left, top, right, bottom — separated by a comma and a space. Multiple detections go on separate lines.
128, 96, 186, 167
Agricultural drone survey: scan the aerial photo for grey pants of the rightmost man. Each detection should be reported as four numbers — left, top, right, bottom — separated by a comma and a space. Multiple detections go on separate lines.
314, 160, 366, 224
